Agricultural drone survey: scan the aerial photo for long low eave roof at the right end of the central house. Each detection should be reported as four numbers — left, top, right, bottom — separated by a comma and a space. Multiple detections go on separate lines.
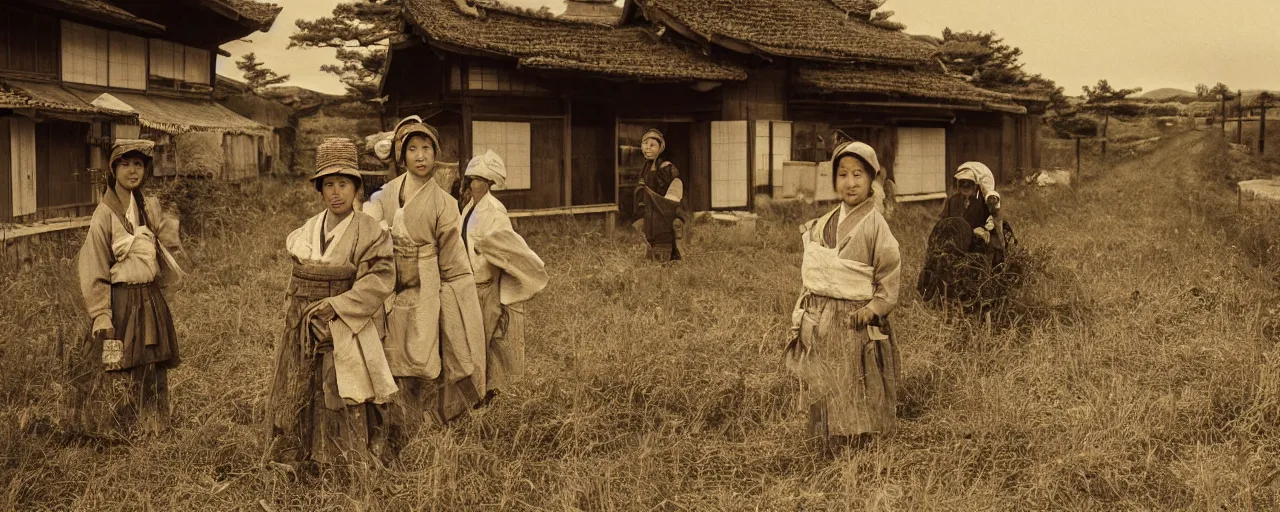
796, 64, 1018, 110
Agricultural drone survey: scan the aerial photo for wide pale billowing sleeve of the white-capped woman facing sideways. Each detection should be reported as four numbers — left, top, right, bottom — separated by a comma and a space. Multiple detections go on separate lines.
471, 215, 548, 305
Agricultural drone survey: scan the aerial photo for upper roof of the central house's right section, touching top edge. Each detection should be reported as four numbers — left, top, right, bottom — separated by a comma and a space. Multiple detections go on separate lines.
632, 0, 937, 64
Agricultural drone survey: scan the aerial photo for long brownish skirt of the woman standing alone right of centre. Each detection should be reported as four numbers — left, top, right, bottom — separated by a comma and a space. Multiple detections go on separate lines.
786, 296, 901, 440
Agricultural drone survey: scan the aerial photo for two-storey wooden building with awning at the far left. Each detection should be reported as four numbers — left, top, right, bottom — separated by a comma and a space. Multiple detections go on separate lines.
0, 0, 279, 224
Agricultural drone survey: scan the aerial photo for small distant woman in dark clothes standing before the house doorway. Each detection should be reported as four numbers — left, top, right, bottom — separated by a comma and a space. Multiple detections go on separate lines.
636, 129, 685, 261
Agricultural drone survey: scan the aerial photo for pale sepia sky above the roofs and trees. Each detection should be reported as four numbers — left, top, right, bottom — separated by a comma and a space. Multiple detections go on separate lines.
218, 0, 1280, 96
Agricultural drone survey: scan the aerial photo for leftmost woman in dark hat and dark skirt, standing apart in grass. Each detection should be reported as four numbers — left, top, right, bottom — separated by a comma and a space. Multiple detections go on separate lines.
72, 140, 182, 435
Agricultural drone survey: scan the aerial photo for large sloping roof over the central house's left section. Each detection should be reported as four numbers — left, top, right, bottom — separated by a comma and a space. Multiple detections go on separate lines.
404, 0, 746, 81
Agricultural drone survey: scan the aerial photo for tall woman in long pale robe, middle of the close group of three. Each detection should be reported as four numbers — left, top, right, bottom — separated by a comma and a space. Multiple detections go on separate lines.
365, 116, 485, 445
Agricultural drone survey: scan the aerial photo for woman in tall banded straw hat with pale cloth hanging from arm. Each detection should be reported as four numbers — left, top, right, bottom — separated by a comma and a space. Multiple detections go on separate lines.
266, 138, 397, 465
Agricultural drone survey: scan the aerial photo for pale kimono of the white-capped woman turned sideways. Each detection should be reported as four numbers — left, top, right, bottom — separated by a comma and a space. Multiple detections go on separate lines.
462, 193, 548, 392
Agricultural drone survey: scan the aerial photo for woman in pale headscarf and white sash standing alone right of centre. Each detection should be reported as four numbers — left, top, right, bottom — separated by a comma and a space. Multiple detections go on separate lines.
785, 142, 901, 454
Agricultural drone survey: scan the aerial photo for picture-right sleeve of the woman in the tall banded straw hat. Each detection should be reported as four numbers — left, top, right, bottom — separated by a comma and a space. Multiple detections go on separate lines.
329, 218, 396, 332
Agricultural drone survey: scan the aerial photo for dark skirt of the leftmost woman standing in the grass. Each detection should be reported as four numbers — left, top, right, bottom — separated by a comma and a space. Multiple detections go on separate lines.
68, 283, 180, 438
